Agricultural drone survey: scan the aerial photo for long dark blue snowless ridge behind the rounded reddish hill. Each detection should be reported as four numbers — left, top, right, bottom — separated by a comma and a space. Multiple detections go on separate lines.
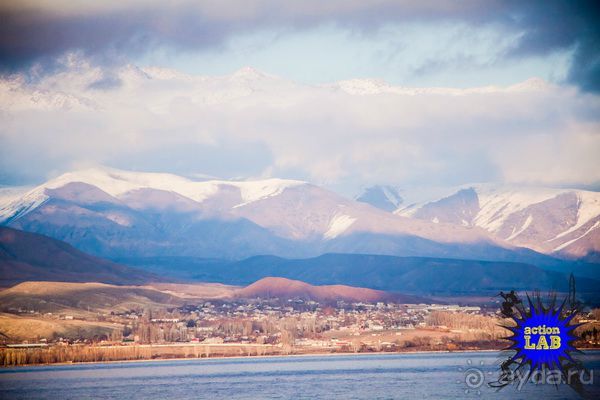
126, 254, 600, 296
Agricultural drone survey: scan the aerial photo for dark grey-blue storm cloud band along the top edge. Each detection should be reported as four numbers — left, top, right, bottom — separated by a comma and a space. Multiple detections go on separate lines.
0, 0, 600, 92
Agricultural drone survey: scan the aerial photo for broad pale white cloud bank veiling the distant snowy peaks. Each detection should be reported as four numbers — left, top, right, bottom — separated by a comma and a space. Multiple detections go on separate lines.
0, 57, 600, 188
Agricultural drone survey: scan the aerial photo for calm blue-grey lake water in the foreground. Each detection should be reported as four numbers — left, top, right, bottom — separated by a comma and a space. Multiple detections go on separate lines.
0, 352, 600, 400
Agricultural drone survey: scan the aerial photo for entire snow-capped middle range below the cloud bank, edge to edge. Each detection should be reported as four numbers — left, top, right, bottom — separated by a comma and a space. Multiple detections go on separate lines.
0, 167, 600, 270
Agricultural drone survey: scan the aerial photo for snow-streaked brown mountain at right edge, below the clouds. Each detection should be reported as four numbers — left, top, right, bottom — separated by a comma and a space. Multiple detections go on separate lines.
384, 184, 600, 261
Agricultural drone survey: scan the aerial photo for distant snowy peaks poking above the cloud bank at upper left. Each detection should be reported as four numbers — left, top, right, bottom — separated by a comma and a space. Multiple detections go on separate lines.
0, 61, 296, 115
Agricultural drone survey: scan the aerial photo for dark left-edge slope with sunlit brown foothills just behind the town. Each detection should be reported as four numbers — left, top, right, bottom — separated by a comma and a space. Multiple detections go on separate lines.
0, 227, 420, 306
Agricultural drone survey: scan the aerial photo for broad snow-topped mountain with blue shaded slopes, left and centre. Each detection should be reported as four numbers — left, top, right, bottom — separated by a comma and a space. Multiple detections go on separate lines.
0, 167, 528, 259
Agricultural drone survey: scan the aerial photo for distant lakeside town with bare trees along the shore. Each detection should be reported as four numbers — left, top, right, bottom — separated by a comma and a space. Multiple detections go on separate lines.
0, 298, 600, 366
